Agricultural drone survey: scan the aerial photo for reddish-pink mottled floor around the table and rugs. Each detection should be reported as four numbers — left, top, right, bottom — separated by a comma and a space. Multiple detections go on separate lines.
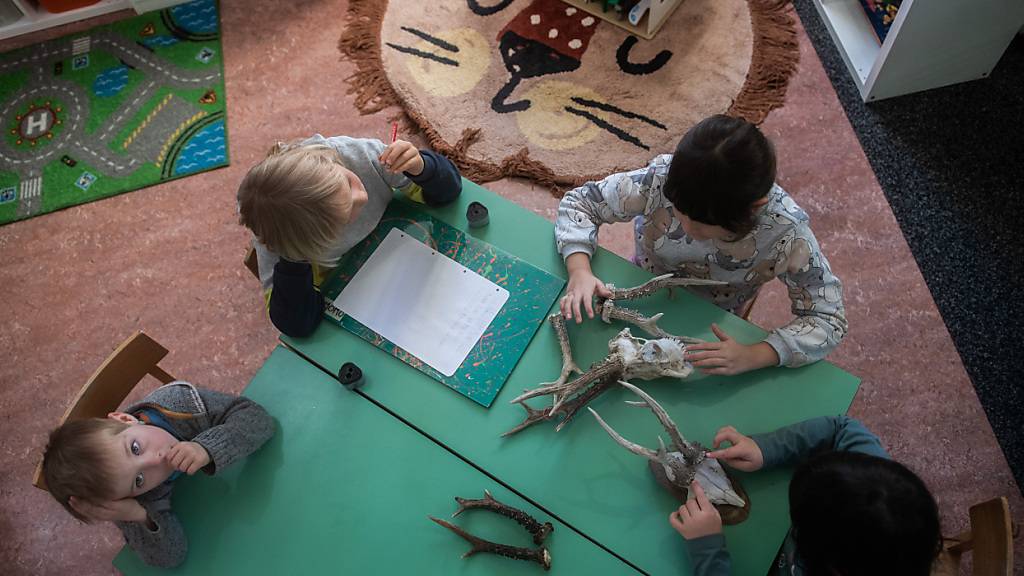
0, 0, 1024, 575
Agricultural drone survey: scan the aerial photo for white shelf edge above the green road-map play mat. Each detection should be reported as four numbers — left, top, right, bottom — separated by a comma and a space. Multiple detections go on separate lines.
0, 0, 184, 40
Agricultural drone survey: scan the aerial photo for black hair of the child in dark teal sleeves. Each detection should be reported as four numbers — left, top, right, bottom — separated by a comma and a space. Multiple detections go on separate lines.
790, 452, 942, 576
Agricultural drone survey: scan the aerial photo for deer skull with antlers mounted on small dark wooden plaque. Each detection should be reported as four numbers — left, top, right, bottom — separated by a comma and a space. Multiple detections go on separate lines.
587, 381, 750, 524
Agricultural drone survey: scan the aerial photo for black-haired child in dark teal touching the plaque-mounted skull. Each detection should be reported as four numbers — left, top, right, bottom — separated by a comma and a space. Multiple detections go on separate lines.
669, 416, 942, 576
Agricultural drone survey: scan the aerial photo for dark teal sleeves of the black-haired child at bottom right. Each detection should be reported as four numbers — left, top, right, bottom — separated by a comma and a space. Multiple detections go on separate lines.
686, 416, 889, 576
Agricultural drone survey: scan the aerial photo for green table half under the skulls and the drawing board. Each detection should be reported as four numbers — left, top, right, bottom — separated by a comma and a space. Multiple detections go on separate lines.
284, 180, 859, 576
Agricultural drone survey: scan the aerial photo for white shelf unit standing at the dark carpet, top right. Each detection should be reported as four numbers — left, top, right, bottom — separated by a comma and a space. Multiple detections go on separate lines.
814, 0, 1024, 101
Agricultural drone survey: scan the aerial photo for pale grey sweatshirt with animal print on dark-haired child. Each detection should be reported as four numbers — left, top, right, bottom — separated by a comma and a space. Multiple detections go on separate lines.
555, 155, 847, 367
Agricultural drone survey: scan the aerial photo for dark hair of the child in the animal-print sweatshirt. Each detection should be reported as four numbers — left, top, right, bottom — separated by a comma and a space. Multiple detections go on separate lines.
663, 114, 775, 235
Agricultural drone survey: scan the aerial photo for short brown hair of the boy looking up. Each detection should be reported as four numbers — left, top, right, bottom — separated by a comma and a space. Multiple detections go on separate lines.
43, 418, 128, 522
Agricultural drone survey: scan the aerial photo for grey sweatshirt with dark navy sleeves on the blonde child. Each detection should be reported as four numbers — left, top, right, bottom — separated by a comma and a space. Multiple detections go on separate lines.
253, 134, 462, 337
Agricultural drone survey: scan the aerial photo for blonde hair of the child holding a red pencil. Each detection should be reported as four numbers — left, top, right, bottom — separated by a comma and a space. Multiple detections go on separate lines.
238, 142, 352, 263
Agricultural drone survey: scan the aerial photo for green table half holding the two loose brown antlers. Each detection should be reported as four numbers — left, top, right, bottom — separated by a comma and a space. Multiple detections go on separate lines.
114, 342, 636, 576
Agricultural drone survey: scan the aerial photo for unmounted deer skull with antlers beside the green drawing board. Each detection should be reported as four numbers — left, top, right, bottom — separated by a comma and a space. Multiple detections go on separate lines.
502, 274, 725, 436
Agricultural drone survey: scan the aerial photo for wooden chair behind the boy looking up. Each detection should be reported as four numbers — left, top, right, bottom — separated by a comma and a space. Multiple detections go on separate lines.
32, 332, 174, 490
